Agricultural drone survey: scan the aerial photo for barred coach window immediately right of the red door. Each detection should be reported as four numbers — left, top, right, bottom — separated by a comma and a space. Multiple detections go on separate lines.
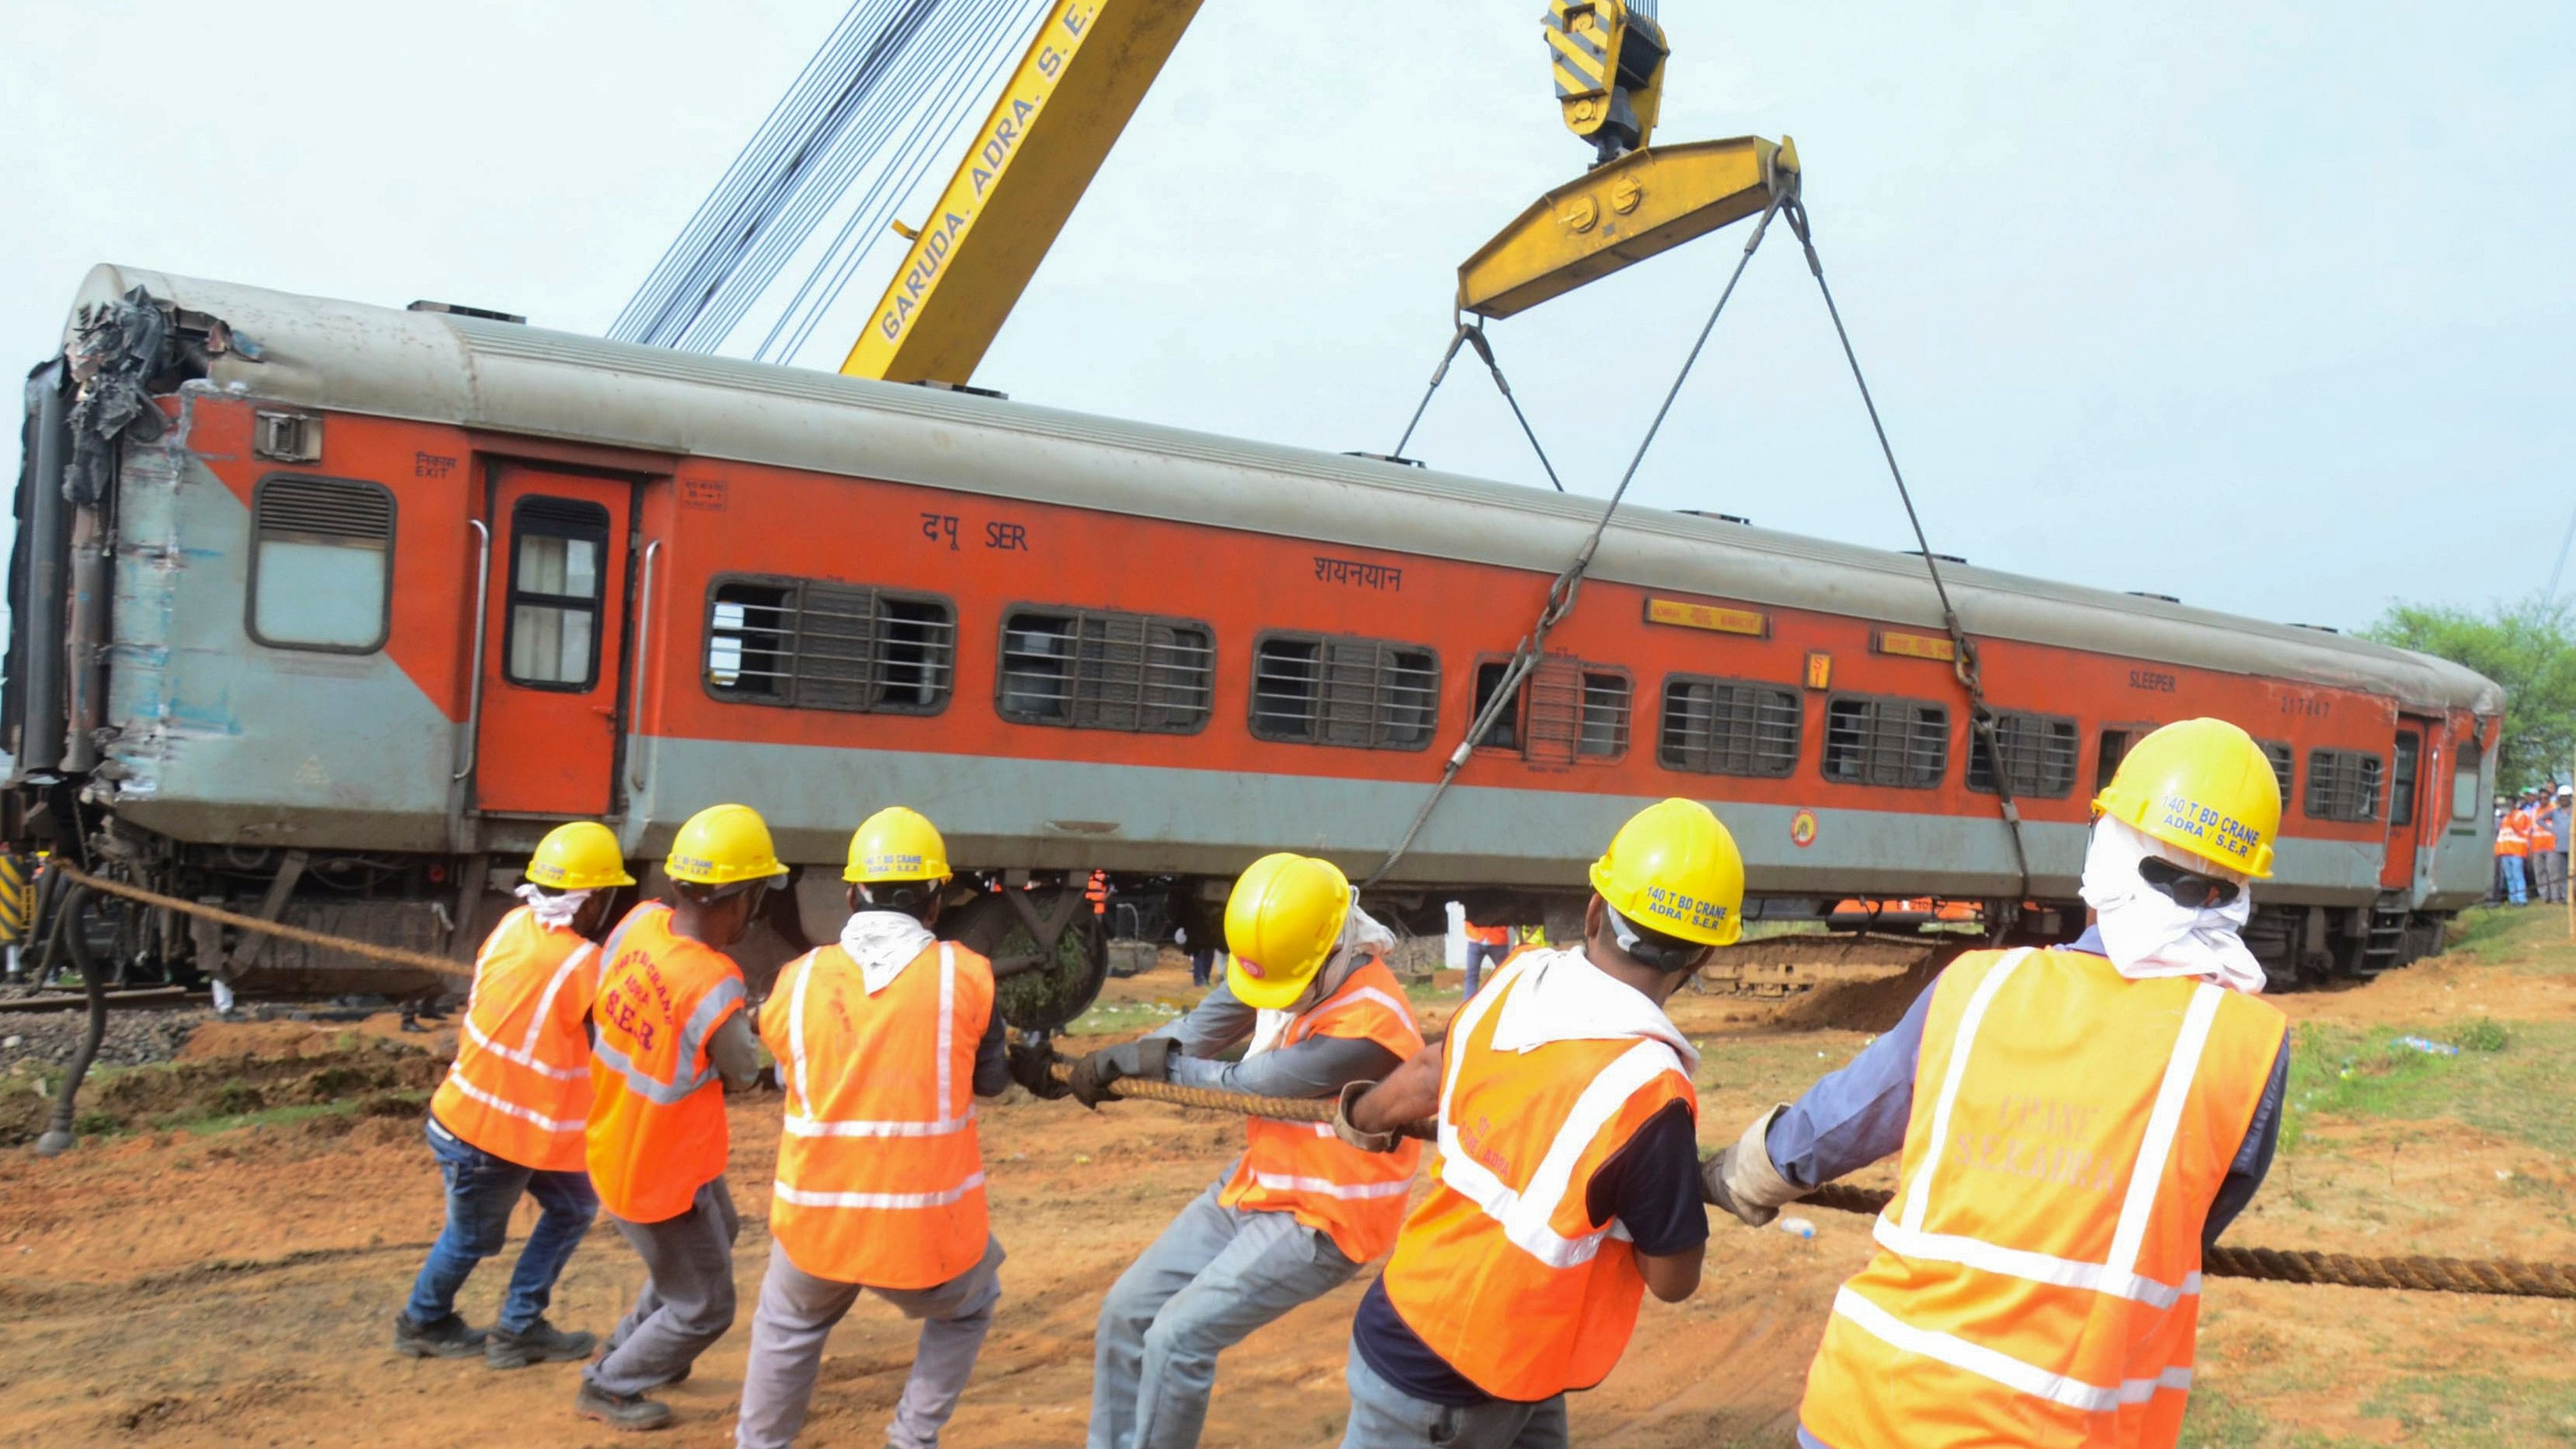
706, 577, 956, 716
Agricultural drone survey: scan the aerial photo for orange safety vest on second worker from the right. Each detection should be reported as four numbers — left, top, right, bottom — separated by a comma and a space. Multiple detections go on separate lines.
1383, 955, 1700, 1403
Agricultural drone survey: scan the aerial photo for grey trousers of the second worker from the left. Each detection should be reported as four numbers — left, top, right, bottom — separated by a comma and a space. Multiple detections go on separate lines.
582, 1176, 742, 1395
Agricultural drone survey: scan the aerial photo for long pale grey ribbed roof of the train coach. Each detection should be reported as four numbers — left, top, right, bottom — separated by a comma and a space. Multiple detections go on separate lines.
75, 265, 2504, 716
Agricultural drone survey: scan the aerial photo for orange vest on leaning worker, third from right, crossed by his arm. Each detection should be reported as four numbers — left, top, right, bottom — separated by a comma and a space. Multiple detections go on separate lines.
1216, 960, 1422, 1264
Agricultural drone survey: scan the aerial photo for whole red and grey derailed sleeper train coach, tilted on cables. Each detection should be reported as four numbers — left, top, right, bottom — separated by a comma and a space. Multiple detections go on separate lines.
0, 268, 2504, 1024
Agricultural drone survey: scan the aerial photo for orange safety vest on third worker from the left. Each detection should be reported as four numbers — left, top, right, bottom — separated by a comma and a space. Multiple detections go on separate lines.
760, 942, 992, 1290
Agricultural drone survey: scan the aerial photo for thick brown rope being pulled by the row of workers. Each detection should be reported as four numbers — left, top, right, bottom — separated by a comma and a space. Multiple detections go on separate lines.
52, 862, 2576, 1300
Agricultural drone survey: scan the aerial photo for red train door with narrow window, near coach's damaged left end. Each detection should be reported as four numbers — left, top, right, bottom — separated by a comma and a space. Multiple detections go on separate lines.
474, 463, 634, 819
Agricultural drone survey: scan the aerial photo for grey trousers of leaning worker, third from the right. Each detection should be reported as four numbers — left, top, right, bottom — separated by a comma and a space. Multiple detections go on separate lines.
1087, 1168, 1360, 1449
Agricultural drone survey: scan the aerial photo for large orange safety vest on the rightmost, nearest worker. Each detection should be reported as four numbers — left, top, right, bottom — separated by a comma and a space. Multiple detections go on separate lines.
1798, 949, 2288, 1449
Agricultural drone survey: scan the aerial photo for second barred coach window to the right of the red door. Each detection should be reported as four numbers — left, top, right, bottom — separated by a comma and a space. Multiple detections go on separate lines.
997, 610, 1216, 733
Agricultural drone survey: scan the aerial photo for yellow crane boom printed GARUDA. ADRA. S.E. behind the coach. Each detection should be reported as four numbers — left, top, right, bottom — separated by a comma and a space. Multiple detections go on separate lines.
840, 0, 1200, 384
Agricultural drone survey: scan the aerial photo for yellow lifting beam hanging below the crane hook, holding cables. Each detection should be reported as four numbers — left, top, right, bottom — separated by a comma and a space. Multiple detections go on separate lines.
1458, 136, 1798, 316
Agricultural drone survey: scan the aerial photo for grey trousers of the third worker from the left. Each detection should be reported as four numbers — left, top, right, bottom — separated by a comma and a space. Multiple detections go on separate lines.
734, 1236, 1002, 1449
